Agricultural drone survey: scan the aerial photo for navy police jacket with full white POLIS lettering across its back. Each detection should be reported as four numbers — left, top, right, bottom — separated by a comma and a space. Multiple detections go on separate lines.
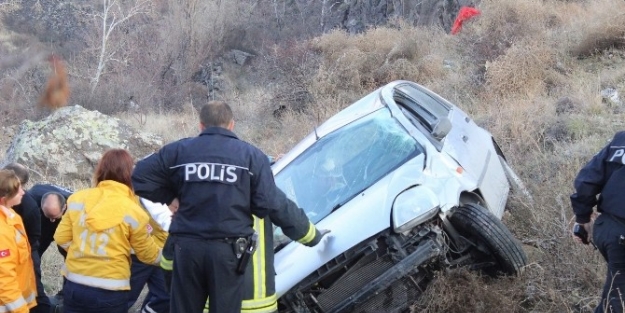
132, 127, 280, 239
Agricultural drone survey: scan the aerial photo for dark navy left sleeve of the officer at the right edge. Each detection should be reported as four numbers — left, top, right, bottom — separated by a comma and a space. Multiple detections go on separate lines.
571, 139, 611, 224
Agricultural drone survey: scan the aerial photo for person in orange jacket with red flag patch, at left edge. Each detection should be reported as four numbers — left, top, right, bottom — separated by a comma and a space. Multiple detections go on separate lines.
0, 170, 37, 313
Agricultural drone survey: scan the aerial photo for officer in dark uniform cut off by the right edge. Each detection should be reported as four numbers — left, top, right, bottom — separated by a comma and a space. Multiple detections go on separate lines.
571, 132, 625, 313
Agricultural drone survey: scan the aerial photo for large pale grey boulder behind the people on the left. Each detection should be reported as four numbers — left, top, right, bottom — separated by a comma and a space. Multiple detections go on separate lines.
0, 105, 163, 182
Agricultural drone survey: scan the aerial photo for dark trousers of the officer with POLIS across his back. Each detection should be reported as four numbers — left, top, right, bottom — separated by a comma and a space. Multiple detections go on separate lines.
171, 237, 244, 313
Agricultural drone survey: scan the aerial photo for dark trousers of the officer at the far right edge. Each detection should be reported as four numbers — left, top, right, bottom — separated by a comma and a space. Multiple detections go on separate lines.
593, 213, 625, 313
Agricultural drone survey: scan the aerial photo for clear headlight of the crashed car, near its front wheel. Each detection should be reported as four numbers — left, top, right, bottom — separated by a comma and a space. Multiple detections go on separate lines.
392, 186, 440, 233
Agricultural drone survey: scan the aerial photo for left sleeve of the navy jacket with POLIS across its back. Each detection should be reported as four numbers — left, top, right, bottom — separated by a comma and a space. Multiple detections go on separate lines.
132, 149, 176, 203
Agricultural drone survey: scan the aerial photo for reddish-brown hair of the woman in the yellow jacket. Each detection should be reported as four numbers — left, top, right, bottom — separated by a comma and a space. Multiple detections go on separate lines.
93, 149, 135, 190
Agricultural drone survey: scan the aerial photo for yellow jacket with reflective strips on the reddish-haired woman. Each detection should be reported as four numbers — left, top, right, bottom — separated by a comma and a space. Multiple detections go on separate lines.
54, 180, 161, 290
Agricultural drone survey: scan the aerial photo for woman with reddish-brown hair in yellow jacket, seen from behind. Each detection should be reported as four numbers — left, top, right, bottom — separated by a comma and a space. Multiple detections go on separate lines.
54, 149, 161, 313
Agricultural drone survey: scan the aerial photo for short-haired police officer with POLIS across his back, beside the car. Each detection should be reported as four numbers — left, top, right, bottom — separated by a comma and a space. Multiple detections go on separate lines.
132, 101, 321, 313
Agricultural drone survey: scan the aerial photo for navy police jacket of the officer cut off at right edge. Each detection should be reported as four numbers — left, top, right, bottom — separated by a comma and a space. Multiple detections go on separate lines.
571, 132, 625, 223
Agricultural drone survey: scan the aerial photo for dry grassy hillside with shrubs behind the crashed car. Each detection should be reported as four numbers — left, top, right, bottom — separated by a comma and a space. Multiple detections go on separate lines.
0, 0, 625, 312
